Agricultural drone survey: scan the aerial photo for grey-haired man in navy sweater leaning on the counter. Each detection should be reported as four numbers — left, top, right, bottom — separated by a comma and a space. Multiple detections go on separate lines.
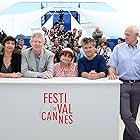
78, 37, 107, 80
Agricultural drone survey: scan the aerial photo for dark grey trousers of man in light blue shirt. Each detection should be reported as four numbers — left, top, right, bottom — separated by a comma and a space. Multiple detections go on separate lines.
120, 82, 140, 140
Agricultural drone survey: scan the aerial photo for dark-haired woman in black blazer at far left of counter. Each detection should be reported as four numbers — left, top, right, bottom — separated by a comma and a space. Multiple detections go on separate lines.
0, 36, 22, 78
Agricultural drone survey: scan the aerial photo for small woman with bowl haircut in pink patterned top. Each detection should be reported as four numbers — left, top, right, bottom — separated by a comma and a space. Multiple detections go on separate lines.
54, 48, 78, 77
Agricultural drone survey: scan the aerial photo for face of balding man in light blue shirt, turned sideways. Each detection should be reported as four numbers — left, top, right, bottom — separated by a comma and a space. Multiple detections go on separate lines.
125, 28, 138, 45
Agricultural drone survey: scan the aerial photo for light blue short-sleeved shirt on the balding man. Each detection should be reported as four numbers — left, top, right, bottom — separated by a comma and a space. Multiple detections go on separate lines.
108, 42, 140, 80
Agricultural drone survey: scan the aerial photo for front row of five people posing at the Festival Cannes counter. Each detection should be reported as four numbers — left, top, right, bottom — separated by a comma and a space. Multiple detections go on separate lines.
0, 26, 140, 140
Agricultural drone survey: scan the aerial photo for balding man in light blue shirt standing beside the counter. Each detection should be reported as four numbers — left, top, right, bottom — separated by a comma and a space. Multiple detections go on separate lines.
108, 26, 140, 140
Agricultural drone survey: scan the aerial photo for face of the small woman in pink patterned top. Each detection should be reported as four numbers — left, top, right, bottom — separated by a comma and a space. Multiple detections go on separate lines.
60, 53, 72, 64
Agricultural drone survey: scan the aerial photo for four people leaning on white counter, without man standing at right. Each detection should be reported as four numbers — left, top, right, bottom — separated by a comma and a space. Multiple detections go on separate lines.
0, 33, 107, 79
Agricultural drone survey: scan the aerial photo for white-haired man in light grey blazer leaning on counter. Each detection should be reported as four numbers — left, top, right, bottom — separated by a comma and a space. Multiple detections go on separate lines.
21, 33, 54, 79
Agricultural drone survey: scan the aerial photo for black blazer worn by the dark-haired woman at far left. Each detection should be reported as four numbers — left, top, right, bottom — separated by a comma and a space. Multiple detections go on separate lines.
0, 54, 21, 72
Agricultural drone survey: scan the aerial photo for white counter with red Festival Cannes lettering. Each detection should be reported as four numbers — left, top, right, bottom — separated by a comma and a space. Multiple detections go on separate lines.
0, 78, 120, 140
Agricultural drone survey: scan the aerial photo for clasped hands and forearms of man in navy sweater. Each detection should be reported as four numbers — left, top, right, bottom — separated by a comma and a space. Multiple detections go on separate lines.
81, 70, 105, 80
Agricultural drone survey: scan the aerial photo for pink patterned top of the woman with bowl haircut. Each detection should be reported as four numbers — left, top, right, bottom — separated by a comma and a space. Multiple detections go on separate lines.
54, 62, 78, 77
